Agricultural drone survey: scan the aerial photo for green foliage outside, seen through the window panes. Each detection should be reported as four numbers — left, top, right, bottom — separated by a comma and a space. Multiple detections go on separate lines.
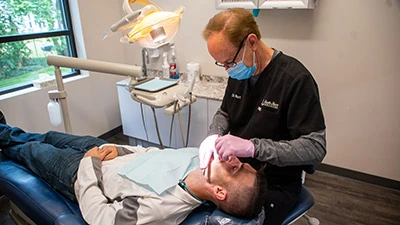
0, 0, 68, 89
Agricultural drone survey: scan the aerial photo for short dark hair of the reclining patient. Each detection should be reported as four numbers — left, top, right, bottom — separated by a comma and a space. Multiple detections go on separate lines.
217, 168, 266, 218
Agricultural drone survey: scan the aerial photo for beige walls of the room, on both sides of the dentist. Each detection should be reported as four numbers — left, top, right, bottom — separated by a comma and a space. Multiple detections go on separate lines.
0, 0, 400, 181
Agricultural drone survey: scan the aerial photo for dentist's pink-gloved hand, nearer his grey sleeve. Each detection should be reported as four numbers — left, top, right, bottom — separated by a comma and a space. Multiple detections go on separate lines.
215, 134, 254, 161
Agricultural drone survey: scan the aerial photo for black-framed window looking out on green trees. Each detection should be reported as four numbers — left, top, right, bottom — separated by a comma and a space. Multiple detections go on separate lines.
0, 0, 78, 94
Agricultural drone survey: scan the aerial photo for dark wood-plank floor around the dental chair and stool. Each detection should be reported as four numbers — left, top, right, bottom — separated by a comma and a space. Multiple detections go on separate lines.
0, 133, 400, 225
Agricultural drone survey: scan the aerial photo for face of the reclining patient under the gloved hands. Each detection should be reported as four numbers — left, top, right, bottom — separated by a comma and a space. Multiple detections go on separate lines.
208, 156, 257, 185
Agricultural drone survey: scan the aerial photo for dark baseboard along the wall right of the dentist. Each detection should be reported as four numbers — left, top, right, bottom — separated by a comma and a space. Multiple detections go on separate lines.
317, 164, 400, 190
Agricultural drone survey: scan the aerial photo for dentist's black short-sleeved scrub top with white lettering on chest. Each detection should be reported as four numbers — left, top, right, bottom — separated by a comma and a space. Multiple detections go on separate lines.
221, 52, 325, 191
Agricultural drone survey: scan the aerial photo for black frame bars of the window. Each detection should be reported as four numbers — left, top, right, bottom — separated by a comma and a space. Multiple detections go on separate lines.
0, 0, 80, 95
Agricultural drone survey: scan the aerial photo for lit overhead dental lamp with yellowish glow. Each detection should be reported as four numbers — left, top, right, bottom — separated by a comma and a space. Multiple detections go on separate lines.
105, 0, 184, 49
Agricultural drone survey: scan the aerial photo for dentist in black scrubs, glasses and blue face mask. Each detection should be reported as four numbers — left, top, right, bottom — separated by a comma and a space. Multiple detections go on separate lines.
199, 9, 326, 225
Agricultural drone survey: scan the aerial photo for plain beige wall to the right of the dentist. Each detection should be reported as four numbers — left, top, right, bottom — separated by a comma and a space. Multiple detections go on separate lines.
253, 0, 400, 180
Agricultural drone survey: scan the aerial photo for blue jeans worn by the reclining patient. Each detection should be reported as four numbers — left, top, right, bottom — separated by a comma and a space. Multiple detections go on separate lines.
0, 124, 107, 202
